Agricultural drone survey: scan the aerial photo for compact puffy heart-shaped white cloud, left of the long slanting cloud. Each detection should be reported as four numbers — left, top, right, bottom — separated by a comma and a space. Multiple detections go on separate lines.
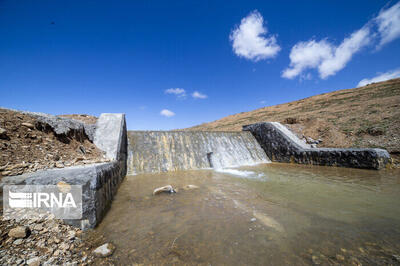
229, 10, 281, 61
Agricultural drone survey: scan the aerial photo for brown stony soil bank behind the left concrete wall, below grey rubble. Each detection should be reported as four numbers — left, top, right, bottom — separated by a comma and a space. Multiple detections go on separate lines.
0, 109, 104, 179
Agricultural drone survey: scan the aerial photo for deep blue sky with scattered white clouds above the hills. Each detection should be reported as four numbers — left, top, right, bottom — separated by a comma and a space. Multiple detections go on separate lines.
0, 0, 400, 129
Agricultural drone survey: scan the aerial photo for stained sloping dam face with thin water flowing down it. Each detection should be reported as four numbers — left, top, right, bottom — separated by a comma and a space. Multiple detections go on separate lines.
128, 131, 270, 175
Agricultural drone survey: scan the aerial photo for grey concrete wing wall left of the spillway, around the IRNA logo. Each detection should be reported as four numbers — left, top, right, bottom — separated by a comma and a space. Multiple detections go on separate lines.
1, 114, 127, 229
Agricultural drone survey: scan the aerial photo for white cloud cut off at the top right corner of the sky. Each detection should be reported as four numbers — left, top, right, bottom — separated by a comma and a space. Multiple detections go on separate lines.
375, 2, 400, 47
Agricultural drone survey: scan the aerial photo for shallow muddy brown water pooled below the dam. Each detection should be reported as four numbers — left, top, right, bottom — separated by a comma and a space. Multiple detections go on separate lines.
96, 163, 400, 265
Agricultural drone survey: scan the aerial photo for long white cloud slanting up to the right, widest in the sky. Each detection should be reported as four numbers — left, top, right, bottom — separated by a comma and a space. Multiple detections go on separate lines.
282, 27, 371, 79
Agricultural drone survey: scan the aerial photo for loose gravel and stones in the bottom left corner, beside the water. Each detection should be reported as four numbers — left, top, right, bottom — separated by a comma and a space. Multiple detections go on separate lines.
0, 210, 115, 266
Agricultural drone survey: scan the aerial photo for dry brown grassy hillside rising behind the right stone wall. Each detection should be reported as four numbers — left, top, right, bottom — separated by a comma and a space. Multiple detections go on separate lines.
185, 79, 400, 155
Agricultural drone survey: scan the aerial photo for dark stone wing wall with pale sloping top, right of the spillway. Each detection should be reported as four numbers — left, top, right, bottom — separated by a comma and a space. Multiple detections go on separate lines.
243, 122, 391, 169
